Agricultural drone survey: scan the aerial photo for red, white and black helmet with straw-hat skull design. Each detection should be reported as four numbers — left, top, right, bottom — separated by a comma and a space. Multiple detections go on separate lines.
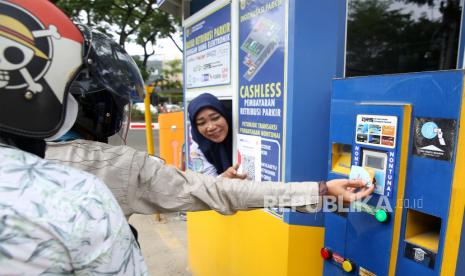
0, 0, 84, 139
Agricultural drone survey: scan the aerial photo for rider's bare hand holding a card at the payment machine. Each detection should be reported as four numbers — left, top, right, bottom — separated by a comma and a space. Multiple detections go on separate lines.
326, 179, 375, 203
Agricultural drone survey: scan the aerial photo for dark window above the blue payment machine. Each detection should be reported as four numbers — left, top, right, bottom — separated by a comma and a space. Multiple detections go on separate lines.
345, 0, 463, 77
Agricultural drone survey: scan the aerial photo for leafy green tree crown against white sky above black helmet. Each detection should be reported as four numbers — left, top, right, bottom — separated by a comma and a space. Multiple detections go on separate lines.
52, 0, 179, 81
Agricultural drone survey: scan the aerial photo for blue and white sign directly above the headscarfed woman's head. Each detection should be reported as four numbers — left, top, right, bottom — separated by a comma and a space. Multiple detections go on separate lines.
184, 4, 231, 89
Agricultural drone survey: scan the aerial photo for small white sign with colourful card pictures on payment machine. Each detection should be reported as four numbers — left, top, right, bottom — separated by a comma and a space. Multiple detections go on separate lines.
355, 115, 397, 149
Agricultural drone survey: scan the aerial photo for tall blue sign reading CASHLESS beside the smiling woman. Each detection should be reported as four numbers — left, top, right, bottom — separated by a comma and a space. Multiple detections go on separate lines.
238, 0, 286, 185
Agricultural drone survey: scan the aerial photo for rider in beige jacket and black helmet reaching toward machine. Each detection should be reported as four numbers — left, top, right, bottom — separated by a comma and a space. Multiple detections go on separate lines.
46, 26, 373, 220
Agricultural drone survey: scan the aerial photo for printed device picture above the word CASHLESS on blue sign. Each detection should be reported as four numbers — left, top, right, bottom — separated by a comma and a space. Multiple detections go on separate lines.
241, 17, 281, 81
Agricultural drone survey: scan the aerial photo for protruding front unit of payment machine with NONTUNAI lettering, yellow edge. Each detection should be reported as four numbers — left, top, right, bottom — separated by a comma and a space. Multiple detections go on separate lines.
322, 102, 411, 275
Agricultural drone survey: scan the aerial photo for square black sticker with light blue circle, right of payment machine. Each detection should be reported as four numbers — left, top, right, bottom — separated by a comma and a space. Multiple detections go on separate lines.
413, 118, 457, 161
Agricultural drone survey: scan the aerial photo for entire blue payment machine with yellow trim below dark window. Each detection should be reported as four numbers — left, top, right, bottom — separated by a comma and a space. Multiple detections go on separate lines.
321, 70, 465, 276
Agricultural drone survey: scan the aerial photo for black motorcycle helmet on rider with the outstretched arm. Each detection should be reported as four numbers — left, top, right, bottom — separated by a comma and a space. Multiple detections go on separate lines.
70, 25, 145, 142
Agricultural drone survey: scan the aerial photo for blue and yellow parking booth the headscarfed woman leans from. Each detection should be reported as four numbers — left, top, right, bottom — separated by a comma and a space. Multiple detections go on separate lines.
170, 0, 345, 275
